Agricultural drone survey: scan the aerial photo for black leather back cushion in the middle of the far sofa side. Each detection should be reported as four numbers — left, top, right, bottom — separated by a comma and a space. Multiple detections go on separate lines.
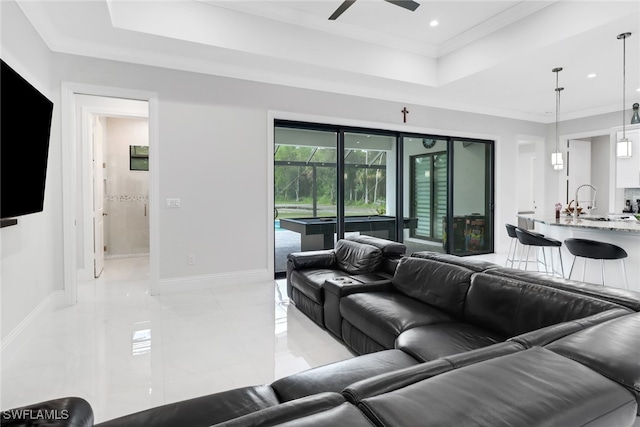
392, 257, 473, 316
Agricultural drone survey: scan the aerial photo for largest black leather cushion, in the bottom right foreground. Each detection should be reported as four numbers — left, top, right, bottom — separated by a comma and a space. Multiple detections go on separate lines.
359, 347, 636, 427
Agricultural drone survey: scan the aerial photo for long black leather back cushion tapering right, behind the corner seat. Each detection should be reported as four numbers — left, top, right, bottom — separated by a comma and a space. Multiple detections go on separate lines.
464, 273, 622, 336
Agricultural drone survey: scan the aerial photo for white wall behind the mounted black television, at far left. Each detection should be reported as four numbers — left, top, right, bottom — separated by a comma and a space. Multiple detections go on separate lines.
0, 1, 63, 347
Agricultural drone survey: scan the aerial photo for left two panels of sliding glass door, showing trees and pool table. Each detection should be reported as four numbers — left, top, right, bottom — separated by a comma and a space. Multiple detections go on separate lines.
274, 121, 397, 275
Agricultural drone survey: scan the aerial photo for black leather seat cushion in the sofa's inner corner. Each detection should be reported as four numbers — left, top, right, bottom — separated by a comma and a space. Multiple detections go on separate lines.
396, 322, 507, 362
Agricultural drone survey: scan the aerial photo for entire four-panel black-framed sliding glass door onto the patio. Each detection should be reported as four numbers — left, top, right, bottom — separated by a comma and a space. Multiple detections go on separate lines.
274, 121, 493, 275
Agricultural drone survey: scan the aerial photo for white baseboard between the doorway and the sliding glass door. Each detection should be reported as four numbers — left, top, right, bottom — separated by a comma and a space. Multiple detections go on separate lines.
160, 268, 273, 294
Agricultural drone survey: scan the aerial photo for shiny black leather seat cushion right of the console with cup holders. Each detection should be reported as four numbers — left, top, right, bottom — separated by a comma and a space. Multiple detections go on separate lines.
340, 292, 455, 349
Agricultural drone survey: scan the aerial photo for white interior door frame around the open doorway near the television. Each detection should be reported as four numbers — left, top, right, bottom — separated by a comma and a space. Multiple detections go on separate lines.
61, 82, 160, 305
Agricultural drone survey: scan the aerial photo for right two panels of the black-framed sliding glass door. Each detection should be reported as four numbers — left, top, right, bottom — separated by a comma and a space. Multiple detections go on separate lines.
402, 135, 493, 255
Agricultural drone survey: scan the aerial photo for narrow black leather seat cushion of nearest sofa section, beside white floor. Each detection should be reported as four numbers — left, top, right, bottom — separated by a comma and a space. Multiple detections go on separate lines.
271, 350, 418, 402
